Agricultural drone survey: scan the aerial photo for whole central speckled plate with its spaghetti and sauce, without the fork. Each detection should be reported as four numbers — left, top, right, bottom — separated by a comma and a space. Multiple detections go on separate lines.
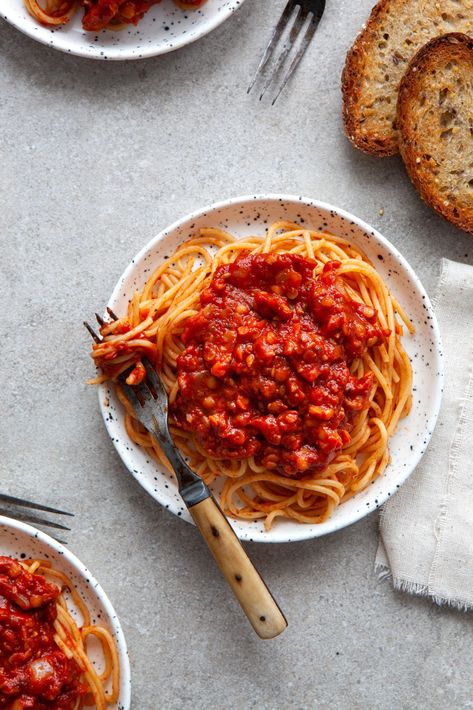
93, 195, 443, 542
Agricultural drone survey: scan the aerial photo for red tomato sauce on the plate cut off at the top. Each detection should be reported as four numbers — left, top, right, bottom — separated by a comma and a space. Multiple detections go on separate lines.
81, 0, 206, 32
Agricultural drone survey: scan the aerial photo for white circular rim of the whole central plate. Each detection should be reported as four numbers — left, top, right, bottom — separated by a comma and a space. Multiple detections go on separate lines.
97, 193, 444, 544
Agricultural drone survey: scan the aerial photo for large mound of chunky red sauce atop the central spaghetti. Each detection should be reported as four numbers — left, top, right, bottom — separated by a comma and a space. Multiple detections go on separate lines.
172, 254, 388, 477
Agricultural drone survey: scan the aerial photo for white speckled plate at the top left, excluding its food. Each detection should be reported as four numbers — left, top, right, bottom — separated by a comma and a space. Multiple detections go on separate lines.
0, 0, 244, 60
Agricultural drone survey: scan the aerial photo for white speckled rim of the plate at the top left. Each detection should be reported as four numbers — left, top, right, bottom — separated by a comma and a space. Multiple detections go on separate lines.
0, 0, 245, 62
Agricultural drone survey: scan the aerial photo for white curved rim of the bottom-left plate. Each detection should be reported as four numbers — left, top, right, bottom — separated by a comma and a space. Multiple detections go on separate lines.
0, 515, 131, 710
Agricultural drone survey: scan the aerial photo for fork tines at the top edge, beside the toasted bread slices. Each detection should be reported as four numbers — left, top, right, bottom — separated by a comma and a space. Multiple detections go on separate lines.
248, 0, 325, 106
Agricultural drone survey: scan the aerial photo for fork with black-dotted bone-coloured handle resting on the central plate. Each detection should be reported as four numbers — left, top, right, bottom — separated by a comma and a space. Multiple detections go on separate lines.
84, 318, 287, 639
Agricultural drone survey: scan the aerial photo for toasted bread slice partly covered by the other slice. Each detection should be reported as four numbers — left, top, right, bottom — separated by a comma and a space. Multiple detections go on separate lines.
342, 0, 473, 157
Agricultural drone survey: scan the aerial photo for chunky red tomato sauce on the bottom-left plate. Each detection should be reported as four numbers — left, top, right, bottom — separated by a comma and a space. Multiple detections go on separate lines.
0, 557, 87, 710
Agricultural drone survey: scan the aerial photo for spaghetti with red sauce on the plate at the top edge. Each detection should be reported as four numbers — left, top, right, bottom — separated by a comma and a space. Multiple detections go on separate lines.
24, 0, 206, 32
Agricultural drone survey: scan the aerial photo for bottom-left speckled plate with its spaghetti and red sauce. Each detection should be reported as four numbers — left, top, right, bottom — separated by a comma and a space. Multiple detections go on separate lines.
0, 516, 130, 710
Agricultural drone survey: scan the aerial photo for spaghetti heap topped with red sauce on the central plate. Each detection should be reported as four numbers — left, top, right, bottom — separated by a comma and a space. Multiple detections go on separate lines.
92, 222, 414, 529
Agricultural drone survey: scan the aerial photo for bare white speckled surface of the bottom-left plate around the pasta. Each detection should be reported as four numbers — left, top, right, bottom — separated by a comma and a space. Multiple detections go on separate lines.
0, 516, 131, 710
